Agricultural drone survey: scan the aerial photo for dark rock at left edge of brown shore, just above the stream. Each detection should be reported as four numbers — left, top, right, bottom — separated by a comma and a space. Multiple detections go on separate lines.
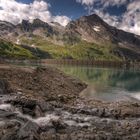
0, 79, 9, 94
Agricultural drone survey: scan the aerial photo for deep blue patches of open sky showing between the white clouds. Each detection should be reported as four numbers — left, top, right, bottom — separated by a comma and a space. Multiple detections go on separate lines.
17, 0, 129, 19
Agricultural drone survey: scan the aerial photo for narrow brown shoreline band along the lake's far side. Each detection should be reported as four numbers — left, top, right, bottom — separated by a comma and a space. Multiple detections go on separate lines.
0, 59, 140, 69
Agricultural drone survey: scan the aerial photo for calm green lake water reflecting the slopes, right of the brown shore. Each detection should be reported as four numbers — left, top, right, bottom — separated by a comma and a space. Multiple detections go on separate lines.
60, 66, 140, 101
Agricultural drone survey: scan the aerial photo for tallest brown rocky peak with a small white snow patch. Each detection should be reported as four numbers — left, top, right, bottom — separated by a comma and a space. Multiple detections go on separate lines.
66, 14, 140, 47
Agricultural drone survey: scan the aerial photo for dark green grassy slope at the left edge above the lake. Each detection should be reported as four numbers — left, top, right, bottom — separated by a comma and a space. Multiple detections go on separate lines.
0, 39, 34, 58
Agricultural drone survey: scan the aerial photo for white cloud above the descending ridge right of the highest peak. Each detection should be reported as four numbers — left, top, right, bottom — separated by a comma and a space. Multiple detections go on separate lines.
99, 1, 140, 35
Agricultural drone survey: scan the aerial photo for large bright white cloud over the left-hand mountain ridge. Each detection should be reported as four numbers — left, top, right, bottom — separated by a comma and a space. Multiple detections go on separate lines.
0, 0, 70, 26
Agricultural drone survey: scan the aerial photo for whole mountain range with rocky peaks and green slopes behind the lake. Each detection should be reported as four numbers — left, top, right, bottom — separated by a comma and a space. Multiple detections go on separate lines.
0, 14, 140, 61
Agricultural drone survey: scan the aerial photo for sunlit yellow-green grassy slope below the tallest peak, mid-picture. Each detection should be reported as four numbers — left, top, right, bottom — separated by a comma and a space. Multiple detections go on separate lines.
21, 36, 121, 60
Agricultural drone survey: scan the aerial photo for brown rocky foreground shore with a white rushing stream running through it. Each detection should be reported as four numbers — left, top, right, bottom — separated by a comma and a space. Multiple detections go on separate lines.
0, 66, 140, 140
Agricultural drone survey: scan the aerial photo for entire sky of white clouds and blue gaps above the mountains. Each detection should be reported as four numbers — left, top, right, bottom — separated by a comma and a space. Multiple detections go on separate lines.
0, 0, 140, 35
